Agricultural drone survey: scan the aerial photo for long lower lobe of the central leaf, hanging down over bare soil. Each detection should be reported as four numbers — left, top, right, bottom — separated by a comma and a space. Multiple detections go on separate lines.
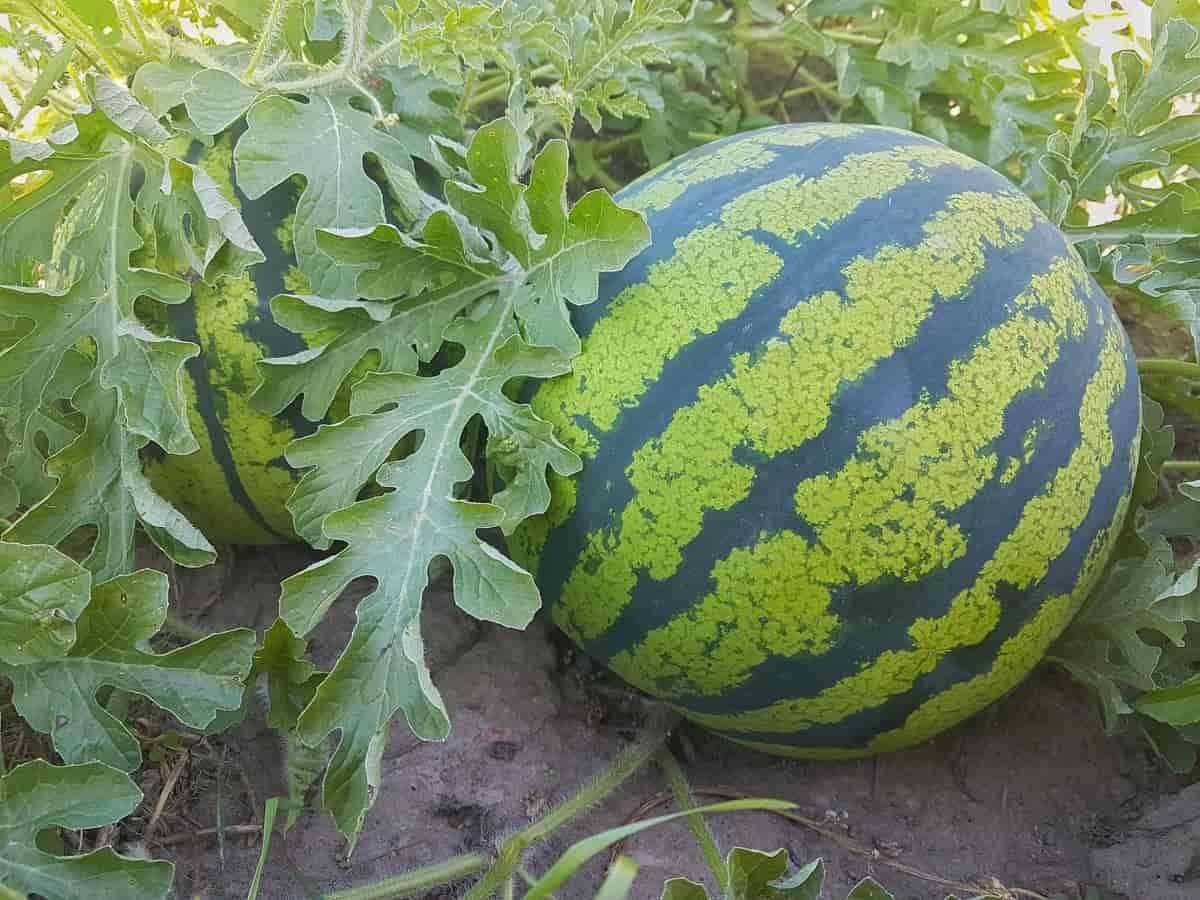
281, 300, 578, 834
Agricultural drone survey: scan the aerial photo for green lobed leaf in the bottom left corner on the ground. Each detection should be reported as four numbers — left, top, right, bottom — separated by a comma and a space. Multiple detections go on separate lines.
0, 760, 174, 900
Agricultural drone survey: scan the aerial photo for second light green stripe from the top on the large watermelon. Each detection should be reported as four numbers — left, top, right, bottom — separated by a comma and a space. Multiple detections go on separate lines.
533, 144, 984, 456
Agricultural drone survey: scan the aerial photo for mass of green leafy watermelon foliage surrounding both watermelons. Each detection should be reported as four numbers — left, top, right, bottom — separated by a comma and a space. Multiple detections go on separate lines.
0, 0, 1200, 896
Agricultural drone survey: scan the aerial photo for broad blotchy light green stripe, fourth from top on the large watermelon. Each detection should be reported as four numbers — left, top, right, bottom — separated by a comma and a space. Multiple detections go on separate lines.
611, 259, 1087, 700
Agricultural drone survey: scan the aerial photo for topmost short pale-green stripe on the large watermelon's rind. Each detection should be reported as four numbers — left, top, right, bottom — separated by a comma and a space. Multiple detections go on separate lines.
622, 124, 862, 212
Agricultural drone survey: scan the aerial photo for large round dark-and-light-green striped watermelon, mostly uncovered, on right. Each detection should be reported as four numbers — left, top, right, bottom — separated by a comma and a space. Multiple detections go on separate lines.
511, 125, 1140, 757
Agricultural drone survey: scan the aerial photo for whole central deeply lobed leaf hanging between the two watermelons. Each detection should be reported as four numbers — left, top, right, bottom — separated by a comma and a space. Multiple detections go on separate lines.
262, 119, 648, 835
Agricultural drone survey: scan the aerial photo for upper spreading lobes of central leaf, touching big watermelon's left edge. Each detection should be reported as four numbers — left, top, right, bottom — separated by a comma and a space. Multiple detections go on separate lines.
248, 119, 649, 427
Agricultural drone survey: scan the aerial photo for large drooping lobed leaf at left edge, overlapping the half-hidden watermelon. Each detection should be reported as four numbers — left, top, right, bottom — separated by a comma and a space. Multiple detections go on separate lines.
0, 77, 262, 581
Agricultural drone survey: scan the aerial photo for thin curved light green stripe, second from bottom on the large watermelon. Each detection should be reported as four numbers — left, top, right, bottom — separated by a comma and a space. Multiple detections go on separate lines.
689, 329, 1126, 733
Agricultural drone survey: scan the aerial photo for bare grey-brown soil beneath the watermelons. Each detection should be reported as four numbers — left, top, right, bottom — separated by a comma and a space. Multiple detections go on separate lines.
152, 547, 1200, 900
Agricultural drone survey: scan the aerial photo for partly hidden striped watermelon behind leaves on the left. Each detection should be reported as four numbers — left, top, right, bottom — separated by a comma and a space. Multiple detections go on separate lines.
145, 133, 316, 545
